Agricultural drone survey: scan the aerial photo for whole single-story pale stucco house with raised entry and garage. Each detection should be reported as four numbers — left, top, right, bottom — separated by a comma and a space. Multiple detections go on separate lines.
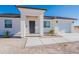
0, 6, 76, 38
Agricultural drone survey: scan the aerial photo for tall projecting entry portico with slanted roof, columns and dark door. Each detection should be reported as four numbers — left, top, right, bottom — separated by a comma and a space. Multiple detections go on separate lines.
18, 6, 46, 38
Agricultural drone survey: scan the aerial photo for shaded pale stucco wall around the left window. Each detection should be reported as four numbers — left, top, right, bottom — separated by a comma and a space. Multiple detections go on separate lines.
0, 17, 20, 35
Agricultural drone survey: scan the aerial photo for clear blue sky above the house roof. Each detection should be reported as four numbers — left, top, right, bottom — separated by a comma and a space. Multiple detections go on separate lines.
0, 5, 79, 25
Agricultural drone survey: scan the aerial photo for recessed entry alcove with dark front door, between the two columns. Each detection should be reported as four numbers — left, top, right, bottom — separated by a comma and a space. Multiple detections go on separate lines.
26, 16, 40, 37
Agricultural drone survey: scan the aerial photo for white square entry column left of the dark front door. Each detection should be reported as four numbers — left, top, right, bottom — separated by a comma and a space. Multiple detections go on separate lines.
20, 14, 26, 38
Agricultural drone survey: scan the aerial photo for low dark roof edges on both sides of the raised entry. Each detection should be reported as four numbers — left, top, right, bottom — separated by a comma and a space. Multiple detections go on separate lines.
0, 13, 77, 20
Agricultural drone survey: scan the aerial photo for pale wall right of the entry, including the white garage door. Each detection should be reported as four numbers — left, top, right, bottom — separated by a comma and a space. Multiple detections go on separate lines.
44, 19, 74, 33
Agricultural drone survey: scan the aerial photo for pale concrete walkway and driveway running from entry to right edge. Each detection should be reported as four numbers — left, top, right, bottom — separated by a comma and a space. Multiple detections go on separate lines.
26, 33, 79, 47
